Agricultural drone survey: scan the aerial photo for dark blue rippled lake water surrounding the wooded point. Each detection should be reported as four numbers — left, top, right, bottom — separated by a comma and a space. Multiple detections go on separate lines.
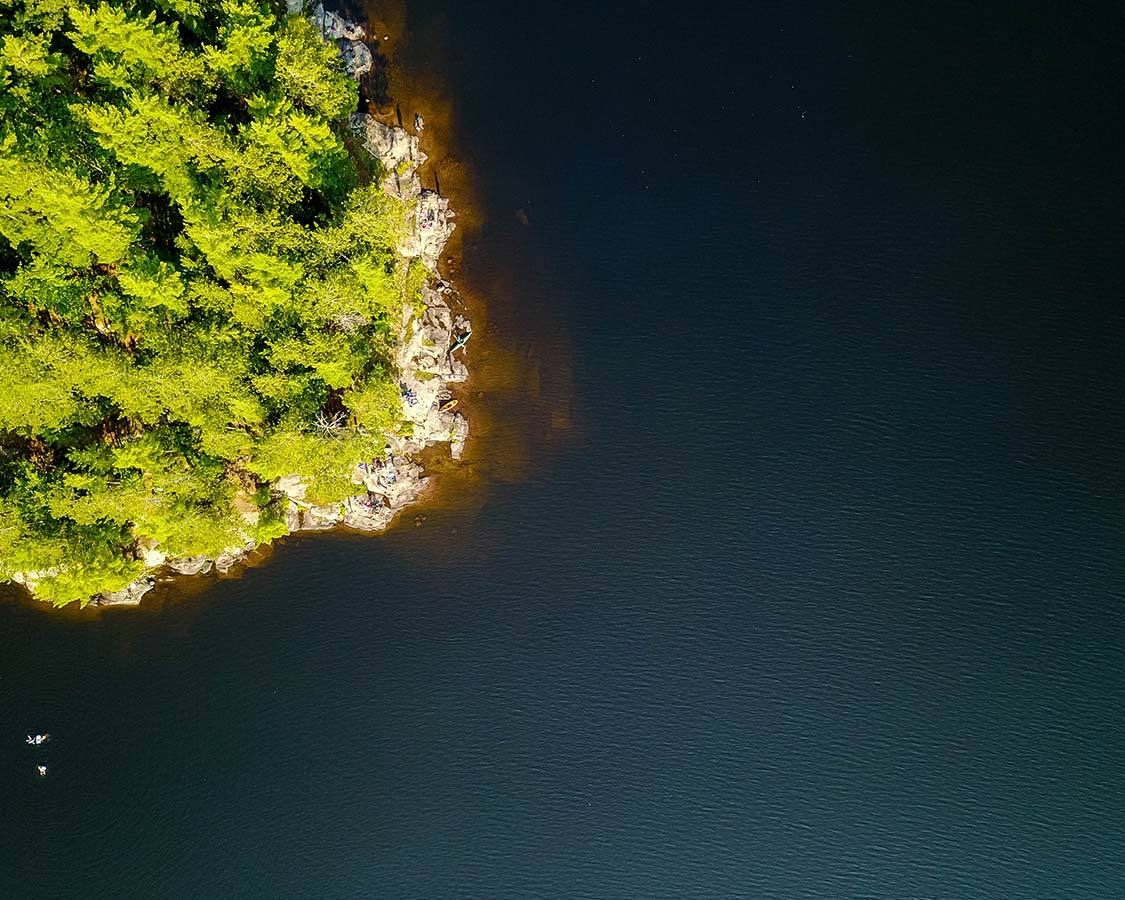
0, 0, 1125, 900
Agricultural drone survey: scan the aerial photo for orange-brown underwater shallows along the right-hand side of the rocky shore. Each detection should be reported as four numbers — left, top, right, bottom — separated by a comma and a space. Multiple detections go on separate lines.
353, 0, 573, 517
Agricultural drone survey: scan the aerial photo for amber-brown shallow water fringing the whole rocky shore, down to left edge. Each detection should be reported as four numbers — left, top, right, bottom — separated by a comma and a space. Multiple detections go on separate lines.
0, 0, 582, 621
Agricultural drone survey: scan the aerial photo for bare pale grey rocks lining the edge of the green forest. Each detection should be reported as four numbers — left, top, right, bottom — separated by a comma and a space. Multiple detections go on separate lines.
85, 0, 471, 606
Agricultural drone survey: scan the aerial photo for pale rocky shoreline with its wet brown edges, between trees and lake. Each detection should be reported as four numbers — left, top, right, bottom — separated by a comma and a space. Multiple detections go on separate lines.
14, 0, 479, 610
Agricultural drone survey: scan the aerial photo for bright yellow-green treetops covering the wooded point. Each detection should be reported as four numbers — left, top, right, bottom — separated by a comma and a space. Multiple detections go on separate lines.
0, 0, 420, 604
